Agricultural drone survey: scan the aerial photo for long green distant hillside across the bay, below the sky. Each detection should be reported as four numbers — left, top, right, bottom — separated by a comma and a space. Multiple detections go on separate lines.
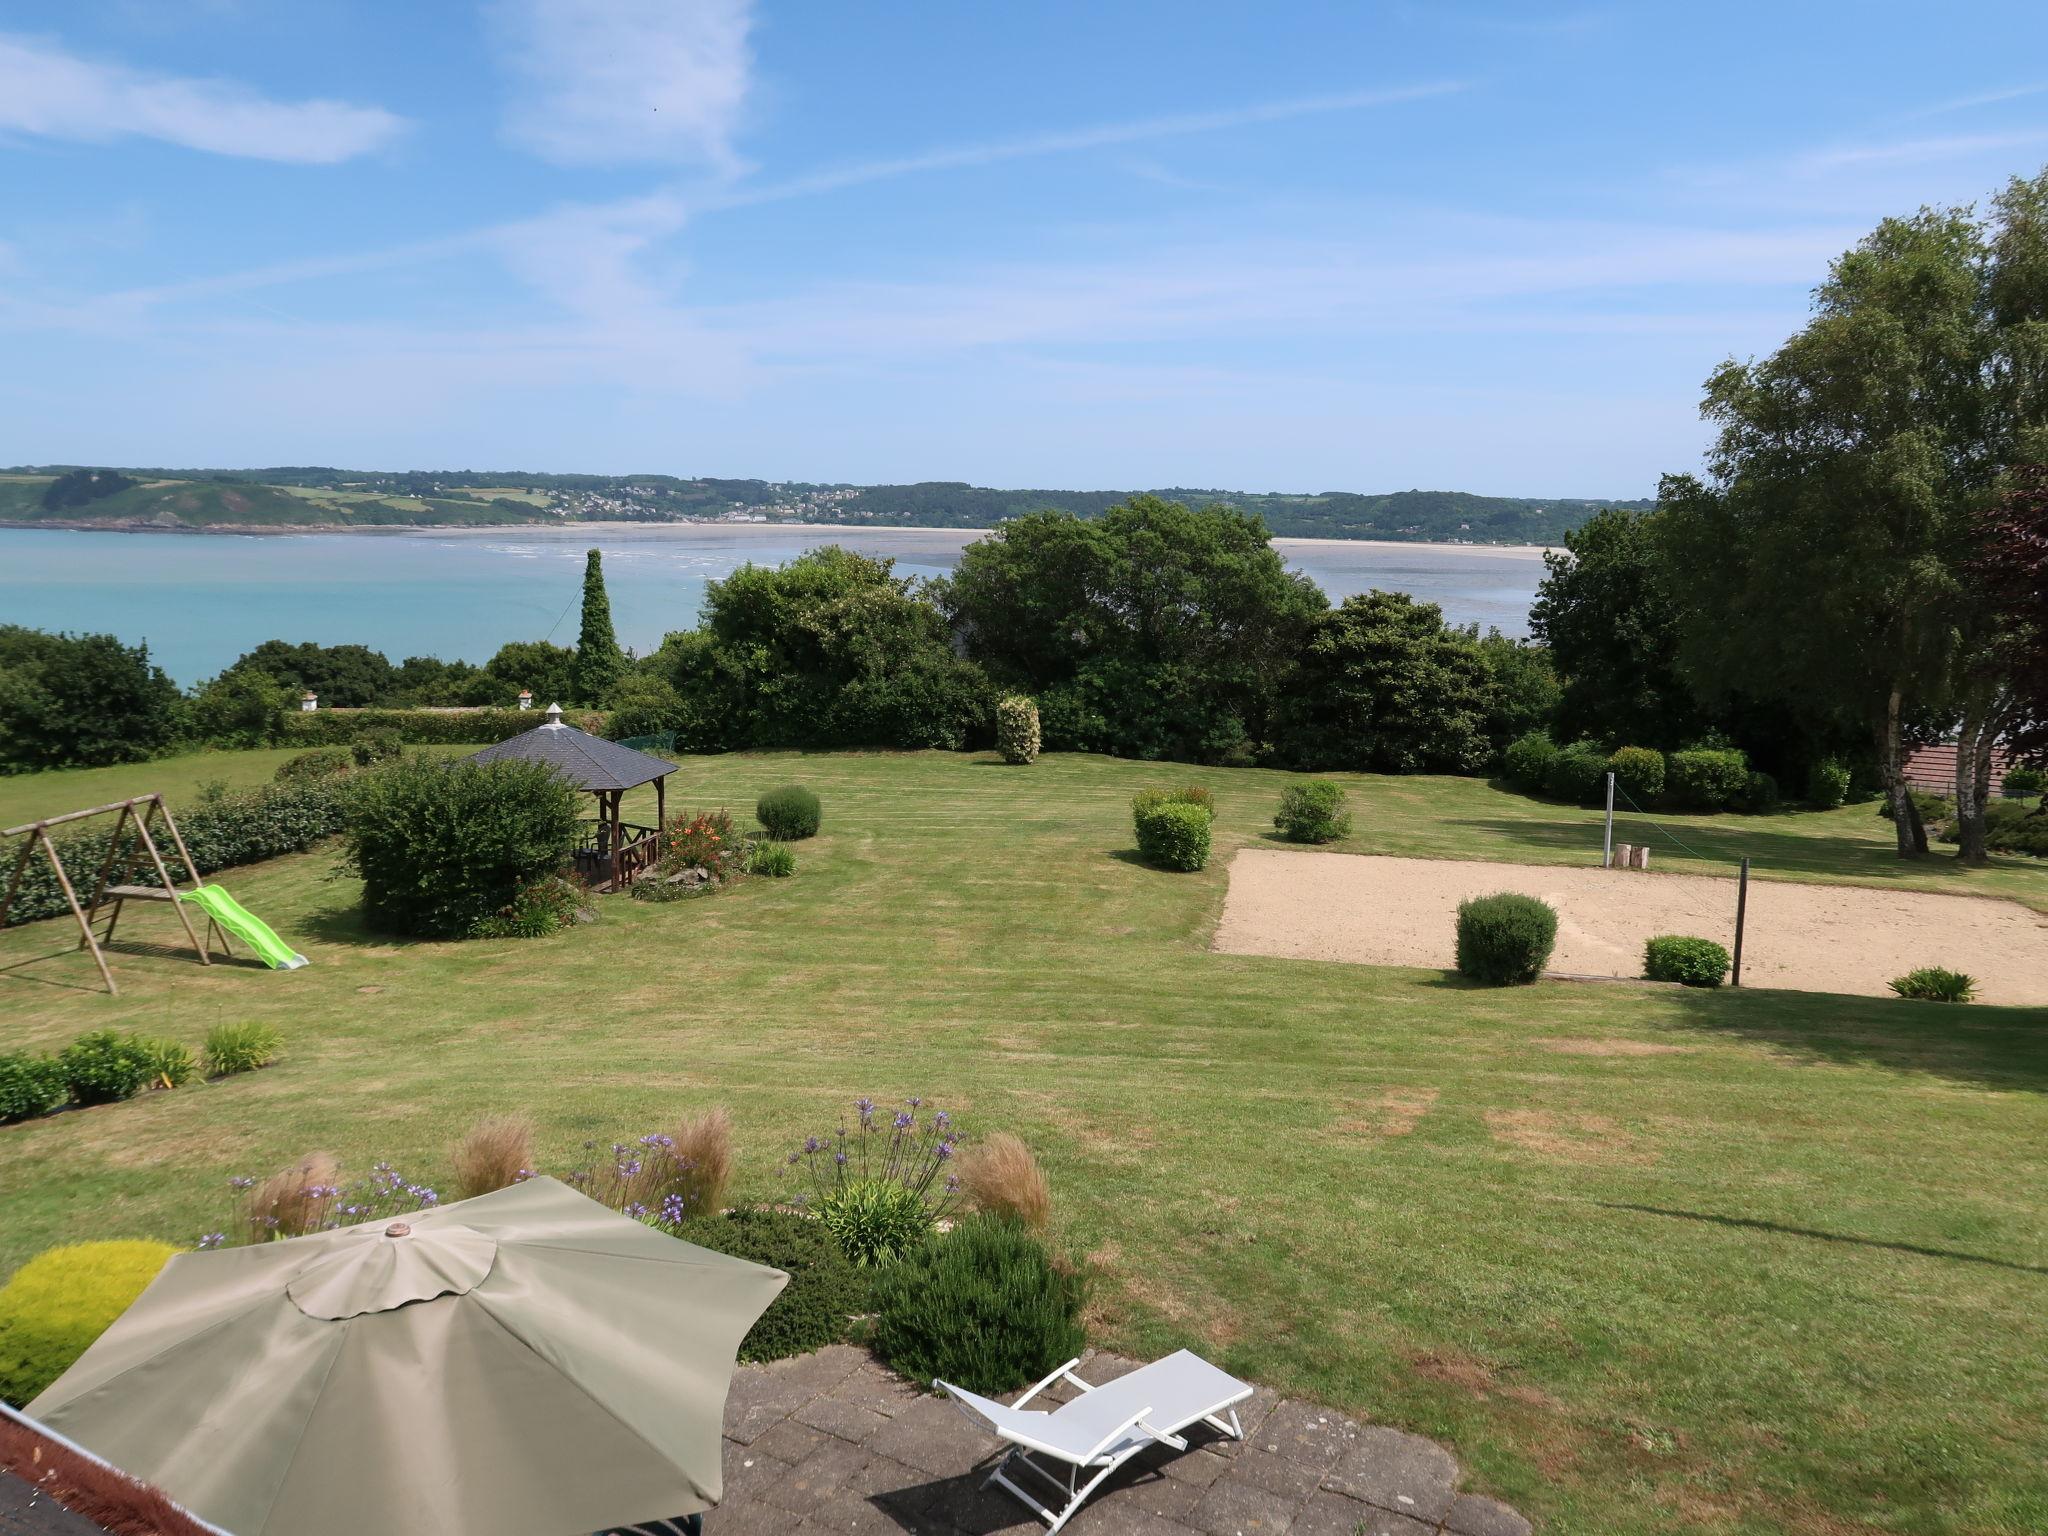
0, 465, 1649, 545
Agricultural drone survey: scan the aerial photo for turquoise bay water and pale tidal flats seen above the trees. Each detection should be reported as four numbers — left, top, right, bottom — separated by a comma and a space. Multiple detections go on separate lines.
0, 524, 1542, 684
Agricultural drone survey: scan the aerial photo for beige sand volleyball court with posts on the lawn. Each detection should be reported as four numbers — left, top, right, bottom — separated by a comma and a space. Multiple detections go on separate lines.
1214, 848, 2048, 1004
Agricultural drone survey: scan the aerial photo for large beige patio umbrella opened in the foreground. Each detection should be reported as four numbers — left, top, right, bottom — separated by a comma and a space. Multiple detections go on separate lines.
29, 1178, 788, 1536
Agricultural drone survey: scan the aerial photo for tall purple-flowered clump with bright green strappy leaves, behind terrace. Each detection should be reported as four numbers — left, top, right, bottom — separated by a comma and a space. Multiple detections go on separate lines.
782, 1098, 961, 1266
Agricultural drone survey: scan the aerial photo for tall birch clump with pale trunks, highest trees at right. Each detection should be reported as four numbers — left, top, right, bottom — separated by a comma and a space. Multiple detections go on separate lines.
1659, 176, 2048, 858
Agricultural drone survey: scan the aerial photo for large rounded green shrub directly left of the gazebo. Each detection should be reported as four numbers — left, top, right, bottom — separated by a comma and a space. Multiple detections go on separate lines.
344, 758, 580, 938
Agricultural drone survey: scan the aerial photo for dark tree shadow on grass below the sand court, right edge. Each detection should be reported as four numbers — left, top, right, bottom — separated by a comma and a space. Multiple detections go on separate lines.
1659, 987, 2048, 1092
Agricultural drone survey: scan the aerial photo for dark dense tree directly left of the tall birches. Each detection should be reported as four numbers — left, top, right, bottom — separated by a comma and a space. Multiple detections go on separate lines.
1530, 508, 1704, 748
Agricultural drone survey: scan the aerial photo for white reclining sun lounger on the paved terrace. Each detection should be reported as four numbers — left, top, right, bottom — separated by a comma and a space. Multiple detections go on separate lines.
932, 1350, 1251, 1530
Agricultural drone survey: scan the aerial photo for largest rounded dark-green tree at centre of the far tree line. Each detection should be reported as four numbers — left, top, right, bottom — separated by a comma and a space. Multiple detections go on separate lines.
938, 496, 1327, 762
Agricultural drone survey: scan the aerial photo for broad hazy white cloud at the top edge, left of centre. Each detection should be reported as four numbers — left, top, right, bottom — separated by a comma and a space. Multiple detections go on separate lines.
489, 0, 754, 174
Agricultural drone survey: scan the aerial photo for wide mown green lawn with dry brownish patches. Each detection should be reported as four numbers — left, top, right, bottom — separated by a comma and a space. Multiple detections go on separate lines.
0, 754, 2048, 1536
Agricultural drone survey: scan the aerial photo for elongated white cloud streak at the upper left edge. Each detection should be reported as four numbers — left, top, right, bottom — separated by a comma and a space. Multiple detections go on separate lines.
0, 33, 406, 166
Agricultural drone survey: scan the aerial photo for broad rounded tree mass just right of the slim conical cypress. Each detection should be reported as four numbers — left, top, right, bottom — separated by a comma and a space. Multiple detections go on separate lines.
651, 545, 991, 750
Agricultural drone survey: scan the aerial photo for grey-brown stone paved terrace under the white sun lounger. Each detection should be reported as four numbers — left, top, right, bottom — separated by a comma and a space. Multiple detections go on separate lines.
705, 1343, 1530, 1536
